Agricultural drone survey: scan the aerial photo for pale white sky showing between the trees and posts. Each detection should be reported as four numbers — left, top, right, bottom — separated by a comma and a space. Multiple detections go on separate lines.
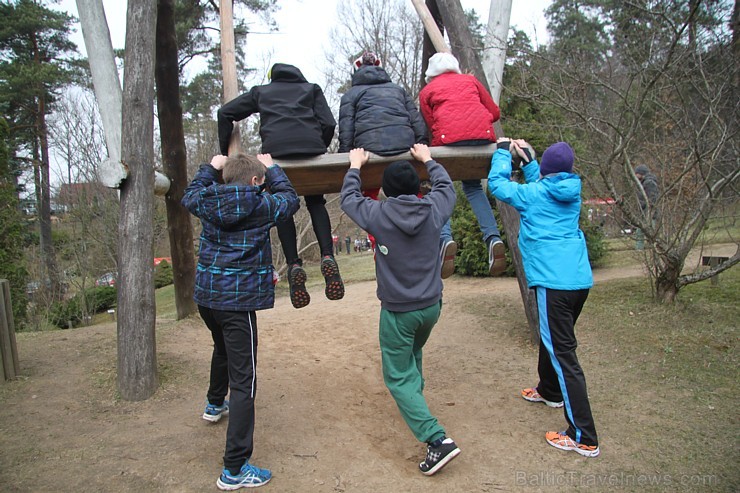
60, 0, 551, 83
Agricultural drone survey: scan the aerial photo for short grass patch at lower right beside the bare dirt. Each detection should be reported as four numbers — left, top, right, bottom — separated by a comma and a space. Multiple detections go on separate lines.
576, 269, 740, 491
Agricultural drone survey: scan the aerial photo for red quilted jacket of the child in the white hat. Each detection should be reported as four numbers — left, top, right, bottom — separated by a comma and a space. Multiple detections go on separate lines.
419, 72, 501, 146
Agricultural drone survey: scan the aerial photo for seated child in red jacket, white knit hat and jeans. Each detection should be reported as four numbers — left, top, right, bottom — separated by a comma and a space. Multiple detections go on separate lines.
419, 53, 506, 276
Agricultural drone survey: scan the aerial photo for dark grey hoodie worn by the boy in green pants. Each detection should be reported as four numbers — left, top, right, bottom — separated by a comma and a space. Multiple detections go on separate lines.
341, 160, 455, 312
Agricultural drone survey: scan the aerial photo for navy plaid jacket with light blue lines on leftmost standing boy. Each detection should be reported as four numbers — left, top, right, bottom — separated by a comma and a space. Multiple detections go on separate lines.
182, 164, 299, 311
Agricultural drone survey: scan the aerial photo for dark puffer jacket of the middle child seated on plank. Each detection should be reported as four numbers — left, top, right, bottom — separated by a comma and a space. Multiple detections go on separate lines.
339, 65, 429, 156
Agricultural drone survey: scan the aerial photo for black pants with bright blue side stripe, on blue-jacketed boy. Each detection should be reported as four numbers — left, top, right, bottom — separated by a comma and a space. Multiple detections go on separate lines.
536, 287, 599, 446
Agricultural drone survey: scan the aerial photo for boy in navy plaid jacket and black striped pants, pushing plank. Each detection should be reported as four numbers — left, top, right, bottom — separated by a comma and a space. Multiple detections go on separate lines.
182, 154, 299, 490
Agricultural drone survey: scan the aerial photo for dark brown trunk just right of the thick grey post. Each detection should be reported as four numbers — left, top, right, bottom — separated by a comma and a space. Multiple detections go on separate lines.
155, 0, 196, 320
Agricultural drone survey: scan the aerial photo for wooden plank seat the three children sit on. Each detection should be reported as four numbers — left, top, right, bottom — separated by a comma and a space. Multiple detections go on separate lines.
275, 144, 496, 196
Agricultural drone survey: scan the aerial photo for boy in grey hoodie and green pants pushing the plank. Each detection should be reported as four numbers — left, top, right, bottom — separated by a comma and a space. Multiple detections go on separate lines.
341, 144, 460, 476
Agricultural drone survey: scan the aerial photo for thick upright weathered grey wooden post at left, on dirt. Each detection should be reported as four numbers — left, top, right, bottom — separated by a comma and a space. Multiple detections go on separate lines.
118, 0, 158, 400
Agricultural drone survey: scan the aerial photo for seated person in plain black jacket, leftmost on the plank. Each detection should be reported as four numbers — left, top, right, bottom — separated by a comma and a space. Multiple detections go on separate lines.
218, 63, 344, 308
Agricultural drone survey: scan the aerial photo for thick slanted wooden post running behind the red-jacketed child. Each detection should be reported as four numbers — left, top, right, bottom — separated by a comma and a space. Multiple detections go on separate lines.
436, 0, 539, 340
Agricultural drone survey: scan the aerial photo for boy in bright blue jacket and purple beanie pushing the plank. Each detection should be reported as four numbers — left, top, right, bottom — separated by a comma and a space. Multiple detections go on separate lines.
488, 139, 599, 457
